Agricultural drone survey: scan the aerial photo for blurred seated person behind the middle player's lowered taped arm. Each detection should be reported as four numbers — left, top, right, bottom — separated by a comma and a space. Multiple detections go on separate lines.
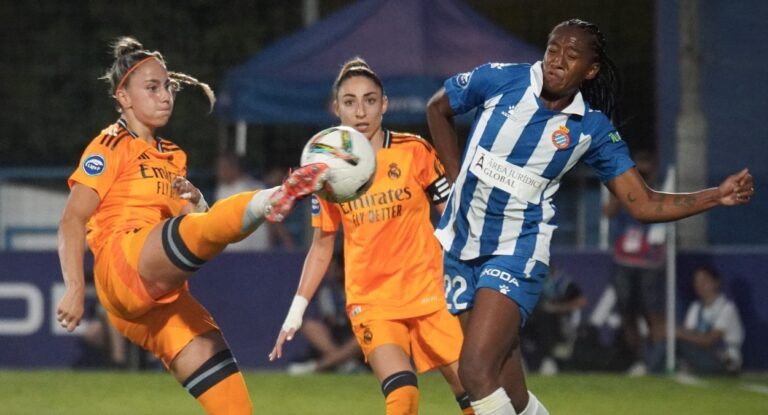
288, 252, 367, 375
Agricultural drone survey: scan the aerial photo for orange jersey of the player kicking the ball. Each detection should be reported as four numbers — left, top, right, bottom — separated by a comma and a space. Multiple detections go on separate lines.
67, 120, 188, 254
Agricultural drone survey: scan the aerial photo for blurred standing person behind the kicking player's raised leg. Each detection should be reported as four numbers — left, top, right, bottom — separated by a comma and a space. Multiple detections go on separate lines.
215, 153, 294, 252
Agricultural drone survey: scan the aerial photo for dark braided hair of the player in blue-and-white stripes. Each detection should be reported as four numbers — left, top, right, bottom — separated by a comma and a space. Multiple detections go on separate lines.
553, 19, 621, 122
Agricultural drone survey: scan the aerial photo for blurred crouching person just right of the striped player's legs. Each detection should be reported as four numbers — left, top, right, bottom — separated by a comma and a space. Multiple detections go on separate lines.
521, 266, 587, 375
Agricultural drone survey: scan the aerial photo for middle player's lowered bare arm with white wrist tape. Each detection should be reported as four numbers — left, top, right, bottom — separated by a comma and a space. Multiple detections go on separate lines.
269, 229, 336, 360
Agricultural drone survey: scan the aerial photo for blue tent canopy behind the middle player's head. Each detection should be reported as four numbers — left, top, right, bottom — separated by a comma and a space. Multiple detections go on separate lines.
217, 0, 542, 124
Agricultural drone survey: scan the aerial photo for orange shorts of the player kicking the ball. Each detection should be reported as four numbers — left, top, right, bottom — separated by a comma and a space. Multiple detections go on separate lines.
93, 224, 219, 366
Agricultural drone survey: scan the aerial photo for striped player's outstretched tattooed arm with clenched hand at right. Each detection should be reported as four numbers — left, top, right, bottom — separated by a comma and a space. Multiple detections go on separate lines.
607, 168, 754, 223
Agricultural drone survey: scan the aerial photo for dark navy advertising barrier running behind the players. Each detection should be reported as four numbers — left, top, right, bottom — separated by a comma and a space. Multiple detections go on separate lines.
0, 251, 768, 370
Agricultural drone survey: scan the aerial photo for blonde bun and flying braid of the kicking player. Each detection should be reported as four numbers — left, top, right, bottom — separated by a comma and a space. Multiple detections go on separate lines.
99, 36, 216, 110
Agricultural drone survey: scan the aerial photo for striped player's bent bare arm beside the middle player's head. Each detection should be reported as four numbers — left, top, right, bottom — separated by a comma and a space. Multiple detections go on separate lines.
427, 88, 461, 183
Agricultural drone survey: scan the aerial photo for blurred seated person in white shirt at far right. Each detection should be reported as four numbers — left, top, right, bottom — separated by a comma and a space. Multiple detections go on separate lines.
675, 267, 744, 374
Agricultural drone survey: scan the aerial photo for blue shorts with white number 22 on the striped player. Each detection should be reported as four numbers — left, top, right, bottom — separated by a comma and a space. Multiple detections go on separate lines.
443, 251, 549, 326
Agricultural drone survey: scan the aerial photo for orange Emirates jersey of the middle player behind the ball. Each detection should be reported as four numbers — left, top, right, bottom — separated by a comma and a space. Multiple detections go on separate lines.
312, 131, 449, 319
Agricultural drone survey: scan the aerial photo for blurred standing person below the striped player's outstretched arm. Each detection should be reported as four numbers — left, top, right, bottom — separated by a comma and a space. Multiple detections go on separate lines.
603, 150, 667, 375
